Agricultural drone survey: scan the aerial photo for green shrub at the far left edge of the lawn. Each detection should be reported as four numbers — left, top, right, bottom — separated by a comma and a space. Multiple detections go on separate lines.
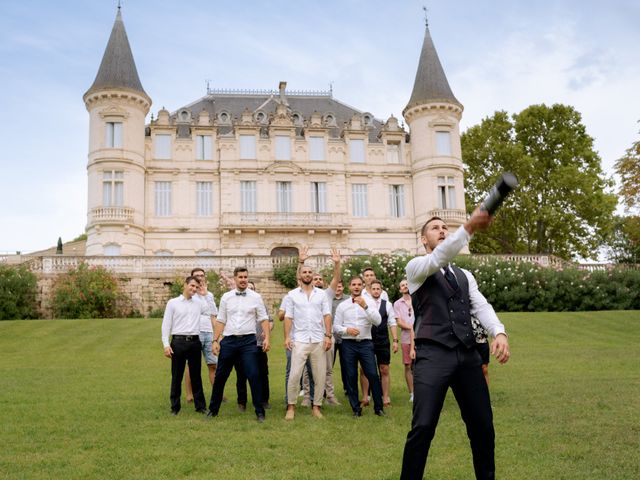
0, 265, 38, 320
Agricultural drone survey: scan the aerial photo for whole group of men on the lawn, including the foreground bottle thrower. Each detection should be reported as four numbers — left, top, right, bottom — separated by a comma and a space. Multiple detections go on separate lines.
162, 209, 510, 479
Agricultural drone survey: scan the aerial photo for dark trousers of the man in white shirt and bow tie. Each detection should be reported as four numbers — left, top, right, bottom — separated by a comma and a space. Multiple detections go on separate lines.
209, 335, 264, 415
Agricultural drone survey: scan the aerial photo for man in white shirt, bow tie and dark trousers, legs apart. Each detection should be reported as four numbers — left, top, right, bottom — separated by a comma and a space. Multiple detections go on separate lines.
208, 267, 271, 422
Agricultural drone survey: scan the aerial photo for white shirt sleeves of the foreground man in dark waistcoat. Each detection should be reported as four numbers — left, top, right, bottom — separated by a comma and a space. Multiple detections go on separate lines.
405, 227, 506, 338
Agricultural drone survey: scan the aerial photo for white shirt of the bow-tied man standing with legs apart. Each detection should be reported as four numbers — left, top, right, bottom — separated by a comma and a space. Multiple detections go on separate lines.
217, 288, 269, 337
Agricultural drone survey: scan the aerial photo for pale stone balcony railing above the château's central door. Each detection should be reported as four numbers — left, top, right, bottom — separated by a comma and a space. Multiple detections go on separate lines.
220, 212, 348, 229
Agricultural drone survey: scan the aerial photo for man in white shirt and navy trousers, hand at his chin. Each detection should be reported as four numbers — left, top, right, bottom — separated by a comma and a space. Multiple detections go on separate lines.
333, 277, 384, 417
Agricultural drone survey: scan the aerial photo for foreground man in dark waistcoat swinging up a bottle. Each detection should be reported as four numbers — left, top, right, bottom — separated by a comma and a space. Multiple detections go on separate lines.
401, 209, 510, 480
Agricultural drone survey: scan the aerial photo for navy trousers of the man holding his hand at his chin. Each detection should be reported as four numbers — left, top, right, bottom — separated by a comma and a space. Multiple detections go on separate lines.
340, 339, 383, 412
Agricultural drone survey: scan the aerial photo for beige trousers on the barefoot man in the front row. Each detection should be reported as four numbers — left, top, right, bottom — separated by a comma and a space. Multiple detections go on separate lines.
287, 342, 327, 406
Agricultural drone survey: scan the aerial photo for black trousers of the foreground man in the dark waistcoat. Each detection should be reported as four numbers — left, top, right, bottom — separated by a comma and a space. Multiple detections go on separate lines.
400, 343, 495, 480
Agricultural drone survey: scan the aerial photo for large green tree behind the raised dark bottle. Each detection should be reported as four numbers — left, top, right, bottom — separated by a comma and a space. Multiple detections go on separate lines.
461, 104, 616, 259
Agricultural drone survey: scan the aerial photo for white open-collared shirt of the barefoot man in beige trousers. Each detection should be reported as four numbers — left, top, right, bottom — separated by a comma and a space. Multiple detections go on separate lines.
285, 287, 331, 343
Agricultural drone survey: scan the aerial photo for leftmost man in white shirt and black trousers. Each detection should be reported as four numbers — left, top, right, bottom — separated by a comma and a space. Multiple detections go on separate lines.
162, 276, 206, 415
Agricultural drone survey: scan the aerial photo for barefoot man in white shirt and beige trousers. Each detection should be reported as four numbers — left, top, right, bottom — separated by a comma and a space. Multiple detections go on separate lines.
284, 266, 333, 420
